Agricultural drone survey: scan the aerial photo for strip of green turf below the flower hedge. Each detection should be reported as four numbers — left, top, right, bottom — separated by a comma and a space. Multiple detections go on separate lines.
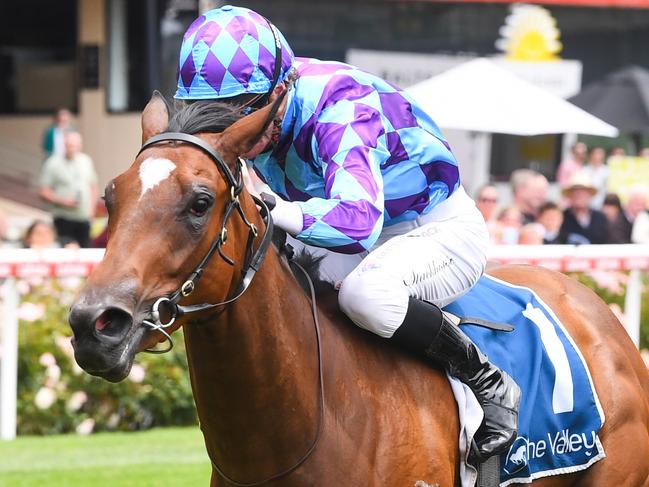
0, 427, 211, 487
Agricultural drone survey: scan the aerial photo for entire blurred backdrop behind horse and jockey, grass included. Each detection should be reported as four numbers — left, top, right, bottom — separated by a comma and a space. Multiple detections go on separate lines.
0, 0, 649, 486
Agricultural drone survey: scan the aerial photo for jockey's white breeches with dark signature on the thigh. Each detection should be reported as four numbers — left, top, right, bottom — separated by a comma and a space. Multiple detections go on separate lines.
291, 188, 489, 338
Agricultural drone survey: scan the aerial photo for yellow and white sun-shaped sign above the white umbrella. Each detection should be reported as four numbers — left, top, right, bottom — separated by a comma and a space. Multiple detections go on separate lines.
496, 4, 563, 61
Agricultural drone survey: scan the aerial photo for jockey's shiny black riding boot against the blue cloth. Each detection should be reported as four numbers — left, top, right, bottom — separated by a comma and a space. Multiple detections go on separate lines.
391, 298, 521, 462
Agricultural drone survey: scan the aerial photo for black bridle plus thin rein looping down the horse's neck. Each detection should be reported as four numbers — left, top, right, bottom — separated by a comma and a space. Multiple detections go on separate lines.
138, 132, 325, 487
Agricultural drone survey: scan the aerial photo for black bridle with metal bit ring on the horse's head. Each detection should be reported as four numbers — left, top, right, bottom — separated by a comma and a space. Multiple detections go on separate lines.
138, 132, 273, 353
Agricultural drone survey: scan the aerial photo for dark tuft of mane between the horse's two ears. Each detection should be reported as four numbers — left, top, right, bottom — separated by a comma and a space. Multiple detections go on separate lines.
167, 100, 244, 135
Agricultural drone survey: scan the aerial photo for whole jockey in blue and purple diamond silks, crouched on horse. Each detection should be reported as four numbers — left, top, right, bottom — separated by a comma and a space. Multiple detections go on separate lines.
175, 5, 520, 461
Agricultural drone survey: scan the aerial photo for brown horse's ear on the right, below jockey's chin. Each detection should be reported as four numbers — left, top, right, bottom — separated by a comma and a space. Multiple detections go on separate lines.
217, 90, 286, 160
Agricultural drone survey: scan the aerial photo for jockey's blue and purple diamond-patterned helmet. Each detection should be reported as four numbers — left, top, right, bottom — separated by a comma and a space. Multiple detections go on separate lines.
175, 5, 295, 100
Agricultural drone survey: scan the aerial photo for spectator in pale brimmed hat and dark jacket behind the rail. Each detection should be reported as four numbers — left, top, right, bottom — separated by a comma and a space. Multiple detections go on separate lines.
559, 171, 608, 245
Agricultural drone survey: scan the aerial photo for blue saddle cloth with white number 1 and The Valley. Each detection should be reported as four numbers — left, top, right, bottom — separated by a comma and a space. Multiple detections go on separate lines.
445, 276, 605, 486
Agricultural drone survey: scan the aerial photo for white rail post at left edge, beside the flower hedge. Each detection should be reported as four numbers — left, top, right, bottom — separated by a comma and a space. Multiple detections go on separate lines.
0, 277, 19, 440
